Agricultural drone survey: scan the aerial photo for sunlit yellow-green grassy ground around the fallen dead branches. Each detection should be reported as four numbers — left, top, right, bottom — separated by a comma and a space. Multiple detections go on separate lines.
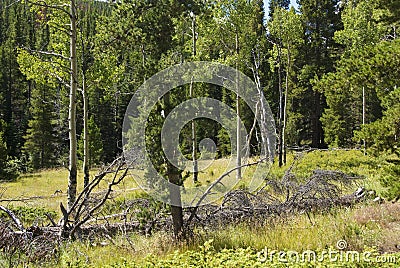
0, 150, 400, 267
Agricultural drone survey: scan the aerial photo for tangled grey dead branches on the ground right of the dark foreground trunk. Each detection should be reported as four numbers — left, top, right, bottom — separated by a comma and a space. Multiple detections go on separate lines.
188, 170, 362, 225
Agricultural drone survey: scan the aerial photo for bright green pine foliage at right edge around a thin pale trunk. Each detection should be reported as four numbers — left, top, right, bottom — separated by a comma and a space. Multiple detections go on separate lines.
316, 40, 400, 149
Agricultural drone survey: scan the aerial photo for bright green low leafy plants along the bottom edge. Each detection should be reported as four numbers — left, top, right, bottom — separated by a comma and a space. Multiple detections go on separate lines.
100, 240, 399, 268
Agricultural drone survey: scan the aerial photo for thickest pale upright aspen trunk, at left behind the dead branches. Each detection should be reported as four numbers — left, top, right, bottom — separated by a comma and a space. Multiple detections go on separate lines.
68, 0, 77, 209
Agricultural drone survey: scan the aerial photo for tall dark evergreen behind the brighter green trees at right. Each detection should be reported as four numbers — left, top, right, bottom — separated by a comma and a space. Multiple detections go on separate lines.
293, 0, 342, 148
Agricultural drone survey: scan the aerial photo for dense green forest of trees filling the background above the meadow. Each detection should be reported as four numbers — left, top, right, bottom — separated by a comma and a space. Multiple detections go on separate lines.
0, 0, 400, 179
